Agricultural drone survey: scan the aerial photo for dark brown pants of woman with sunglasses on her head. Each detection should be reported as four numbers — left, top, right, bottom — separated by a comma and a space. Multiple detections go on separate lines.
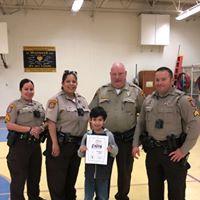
46, 139, 81, 200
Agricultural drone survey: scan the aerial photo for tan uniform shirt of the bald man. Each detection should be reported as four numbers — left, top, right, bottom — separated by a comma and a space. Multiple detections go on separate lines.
89, 83, 144, 132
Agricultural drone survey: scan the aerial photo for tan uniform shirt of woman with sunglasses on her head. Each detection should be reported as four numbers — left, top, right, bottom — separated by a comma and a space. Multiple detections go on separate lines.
46, 91, 90, 136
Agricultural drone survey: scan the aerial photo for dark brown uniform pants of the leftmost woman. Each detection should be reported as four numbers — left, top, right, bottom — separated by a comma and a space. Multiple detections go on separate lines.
7, 139, 42, 200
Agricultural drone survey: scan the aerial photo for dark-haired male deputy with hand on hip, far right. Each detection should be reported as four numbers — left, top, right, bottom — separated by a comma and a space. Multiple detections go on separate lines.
132, 67, 200, 200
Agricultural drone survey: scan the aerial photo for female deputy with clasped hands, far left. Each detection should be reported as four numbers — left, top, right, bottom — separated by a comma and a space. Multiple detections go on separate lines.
5, 79, 45, 200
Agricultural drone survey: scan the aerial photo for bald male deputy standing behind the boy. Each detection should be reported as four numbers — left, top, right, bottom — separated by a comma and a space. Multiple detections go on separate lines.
89, 63, 144, 200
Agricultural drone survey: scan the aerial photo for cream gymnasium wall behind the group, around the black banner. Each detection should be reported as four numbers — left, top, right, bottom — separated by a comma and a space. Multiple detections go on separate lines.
0, 11, 200, 116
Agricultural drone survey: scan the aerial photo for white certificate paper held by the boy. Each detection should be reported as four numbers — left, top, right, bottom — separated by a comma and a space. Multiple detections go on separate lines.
85, 135, 108, 165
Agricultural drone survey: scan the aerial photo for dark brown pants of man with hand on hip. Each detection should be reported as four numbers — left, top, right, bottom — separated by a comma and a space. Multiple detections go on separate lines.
146, 147, 189, 200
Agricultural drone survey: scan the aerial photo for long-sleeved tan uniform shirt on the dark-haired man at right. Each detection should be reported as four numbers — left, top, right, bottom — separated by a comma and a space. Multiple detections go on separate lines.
133, 88, 200, 153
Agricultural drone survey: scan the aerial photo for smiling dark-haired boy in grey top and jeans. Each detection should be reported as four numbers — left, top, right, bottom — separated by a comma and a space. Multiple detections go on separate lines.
78, 106, 118, 200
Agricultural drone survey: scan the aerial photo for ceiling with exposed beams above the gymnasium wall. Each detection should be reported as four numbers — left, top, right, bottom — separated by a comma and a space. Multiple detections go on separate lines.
0, 0, 200, 15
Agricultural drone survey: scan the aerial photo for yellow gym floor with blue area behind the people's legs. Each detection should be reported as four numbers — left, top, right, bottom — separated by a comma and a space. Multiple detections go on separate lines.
0, 121, 200, 200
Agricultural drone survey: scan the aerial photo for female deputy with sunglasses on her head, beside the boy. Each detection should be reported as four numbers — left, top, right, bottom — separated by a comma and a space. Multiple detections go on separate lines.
46, 70, 89, 200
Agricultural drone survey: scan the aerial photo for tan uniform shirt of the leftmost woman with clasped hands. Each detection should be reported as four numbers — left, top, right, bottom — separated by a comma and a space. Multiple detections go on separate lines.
5, 98, 45, 127
